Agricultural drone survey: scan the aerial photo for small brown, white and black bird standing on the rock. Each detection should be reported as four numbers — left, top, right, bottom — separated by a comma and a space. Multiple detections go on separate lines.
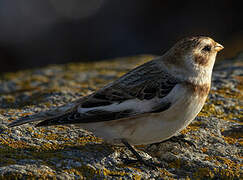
8, 36, 224, 167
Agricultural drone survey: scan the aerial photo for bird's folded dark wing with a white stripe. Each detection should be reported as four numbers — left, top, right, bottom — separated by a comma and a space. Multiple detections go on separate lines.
34, 61, 179, 126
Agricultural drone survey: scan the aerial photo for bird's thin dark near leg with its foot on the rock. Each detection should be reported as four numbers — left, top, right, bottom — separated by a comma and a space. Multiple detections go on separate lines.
122, 139, 162, 169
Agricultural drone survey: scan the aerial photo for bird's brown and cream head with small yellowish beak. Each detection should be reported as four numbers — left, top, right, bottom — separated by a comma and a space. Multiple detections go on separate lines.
165, 36, 224, 84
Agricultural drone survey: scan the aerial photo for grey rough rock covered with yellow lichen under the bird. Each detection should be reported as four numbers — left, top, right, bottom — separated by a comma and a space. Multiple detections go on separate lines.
0, 55, 243, 179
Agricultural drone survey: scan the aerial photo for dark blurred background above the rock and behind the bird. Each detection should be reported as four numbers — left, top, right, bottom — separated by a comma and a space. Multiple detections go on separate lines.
0, 0, 243, 72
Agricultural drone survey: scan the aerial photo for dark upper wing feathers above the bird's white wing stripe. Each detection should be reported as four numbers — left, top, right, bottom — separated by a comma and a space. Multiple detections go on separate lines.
81, 61, 179, 108
